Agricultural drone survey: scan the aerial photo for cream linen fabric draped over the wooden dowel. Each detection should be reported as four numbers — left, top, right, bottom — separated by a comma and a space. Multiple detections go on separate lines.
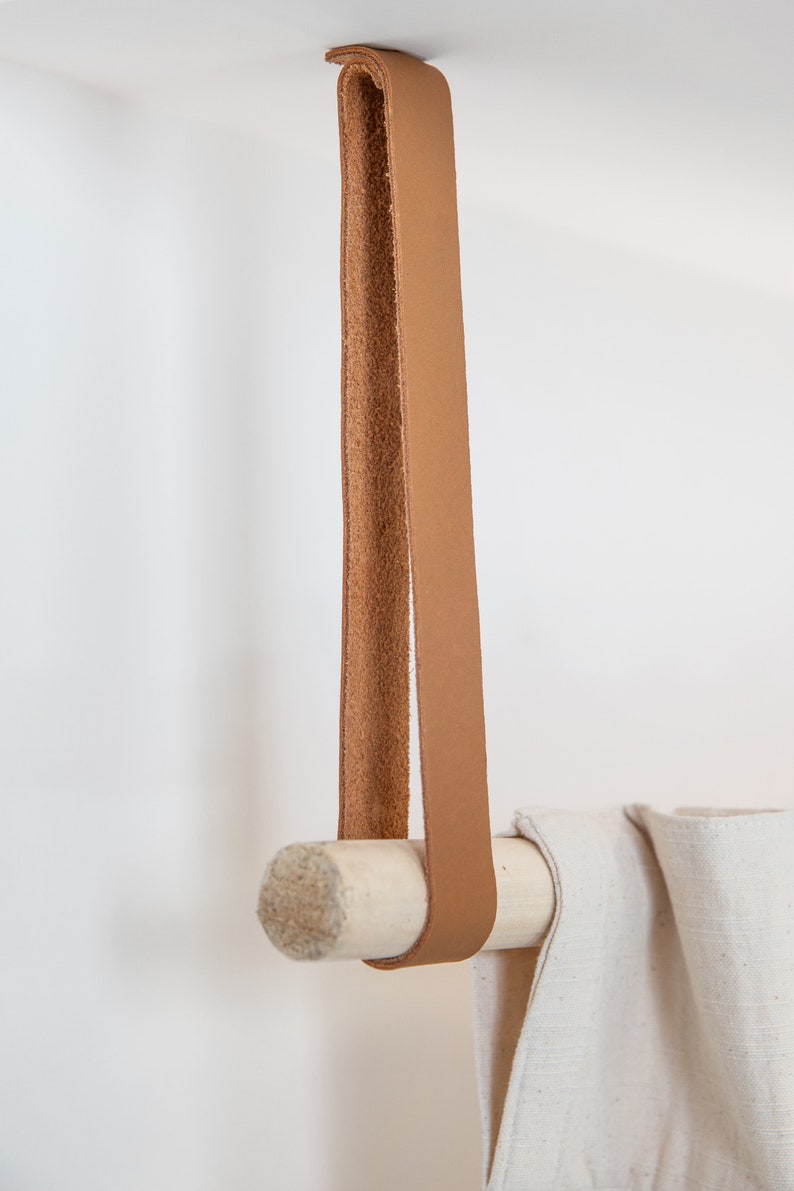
473, 805, 794, 1191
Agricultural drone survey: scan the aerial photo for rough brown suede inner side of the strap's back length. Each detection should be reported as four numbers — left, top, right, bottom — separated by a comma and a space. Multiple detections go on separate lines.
339, 66, 409, 840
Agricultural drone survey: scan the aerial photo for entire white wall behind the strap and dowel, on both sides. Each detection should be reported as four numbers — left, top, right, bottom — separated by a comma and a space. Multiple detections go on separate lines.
0, 55, 794, 1191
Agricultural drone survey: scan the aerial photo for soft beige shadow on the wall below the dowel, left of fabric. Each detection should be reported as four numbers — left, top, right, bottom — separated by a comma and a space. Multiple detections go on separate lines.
323, 964, 481, 1191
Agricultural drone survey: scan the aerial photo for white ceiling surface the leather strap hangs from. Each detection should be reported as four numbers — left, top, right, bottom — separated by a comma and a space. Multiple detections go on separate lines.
0, 0, 794, 295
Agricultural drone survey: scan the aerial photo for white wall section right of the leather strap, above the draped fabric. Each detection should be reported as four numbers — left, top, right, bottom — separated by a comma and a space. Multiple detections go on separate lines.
462, 210, 794, 824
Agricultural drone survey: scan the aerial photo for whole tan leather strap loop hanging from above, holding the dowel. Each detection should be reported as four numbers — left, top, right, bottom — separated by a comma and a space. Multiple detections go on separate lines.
327, 46, 496, 967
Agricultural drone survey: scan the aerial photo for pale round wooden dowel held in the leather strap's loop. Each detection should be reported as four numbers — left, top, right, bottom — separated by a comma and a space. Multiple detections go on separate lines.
258, 837, 555, 960
